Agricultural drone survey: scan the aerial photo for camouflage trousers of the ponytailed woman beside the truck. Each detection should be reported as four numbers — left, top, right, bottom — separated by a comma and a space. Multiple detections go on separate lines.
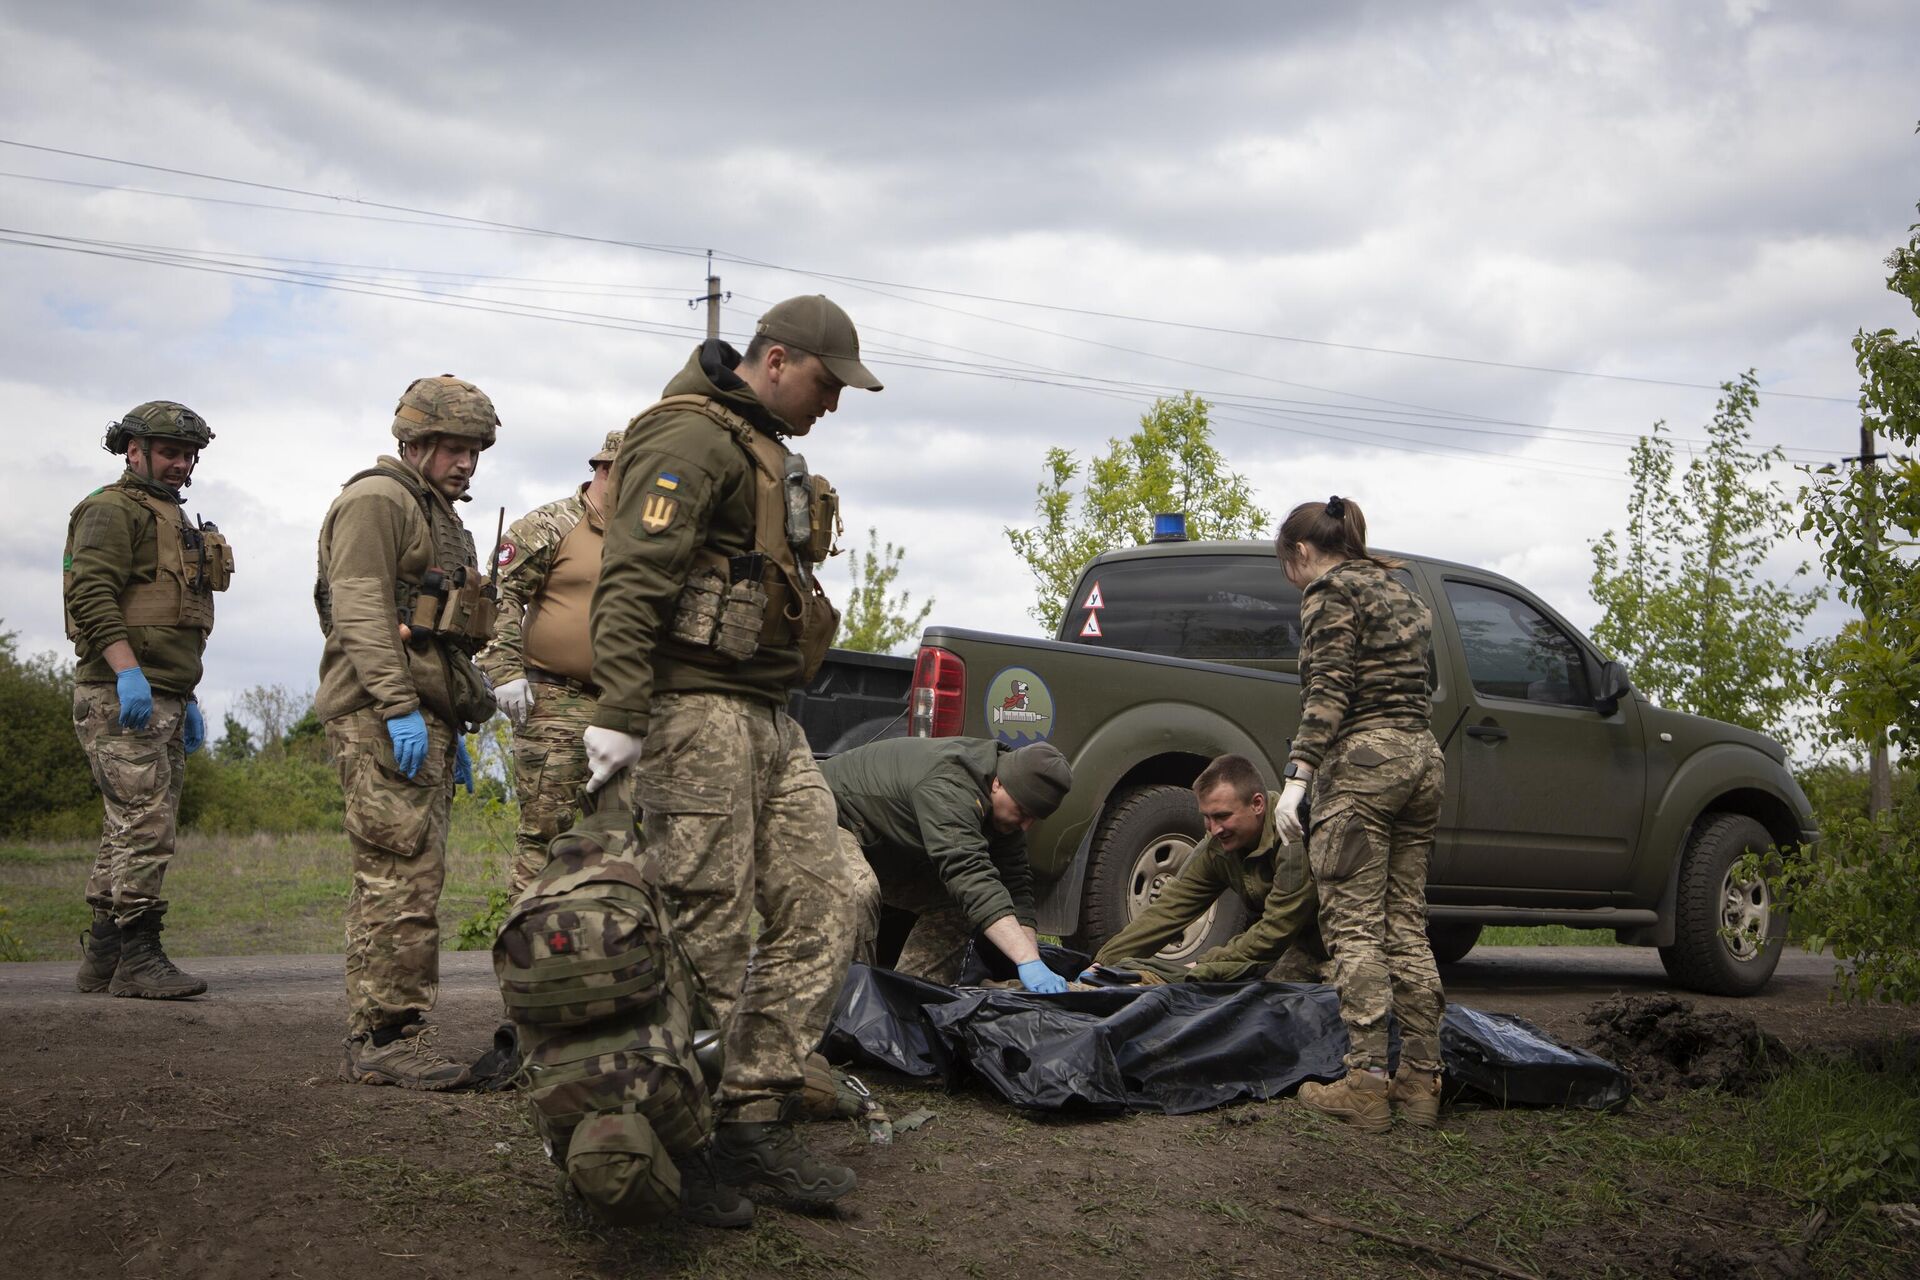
1308, 729, 1446, 1071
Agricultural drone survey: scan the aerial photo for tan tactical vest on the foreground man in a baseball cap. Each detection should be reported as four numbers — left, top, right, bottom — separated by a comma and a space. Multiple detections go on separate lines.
629, 393, 843, 679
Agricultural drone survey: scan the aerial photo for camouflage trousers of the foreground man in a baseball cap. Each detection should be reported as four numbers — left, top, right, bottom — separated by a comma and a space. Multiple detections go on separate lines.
634, 693, 872, 1121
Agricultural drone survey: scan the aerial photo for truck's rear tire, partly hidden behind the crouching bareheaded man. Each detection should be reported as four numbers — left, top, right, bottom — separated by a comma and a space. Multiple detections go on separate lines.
1075, 787, 1246, 961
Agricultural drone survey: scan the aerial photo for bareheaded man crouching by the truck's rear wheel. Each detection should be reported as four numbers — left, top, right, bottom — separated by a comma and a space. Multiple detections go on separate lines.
1081, 756, 1327, 983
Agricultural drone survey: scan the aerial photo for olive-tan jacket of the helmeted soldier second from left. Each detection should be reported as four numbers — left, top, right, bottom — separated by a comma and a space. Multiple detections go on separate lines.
313, 457, 478, 723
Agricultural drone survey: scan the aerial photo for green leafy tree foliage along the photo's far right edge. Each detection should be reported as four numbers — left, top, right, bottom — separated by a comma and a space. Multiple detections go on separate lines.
1774, 188, 1920, 1004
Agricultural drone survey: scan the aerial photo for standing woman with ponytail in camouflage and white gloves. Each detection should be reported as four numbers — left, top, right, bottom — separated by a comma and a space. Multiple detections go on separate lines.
1277, 497, 1446, 1132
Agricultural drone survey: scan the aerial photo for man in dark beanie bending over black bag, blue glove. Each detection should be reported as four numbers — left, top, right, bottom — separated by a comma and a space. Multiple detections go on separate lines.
822, 737, 1073, 992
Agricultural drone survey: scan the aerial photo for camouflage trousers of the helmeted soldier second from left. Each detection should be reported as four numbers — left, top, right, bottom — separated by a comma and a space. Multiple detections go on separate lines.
326, 706, 453, 1038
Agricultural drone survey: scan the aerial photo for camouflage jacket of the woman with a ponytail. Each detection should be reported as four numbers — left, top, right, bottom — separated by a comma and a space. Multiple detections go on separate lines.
1292, 560, 1434, 770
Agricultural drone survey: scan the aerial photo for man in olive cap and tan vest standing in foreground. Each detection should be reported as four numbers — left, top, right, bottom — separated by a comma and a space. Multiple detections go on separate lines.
586, 296, 879, 1209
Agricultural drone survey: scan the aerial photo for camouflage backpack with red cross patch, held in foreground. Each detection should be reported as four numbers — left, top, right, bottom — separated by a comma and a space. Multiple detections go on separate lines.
493, 810, 712, 1222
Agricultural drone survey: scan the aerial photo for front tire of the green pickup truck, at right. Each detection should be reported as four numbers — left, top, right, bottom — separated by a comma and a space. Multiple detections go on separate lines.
1661, 814, 1788, 996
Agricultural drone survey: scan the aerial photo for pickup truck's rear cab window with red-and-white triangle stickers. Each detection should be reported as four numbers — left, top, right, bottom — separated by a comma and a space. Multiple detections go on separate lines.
1060, 555, 1300, 660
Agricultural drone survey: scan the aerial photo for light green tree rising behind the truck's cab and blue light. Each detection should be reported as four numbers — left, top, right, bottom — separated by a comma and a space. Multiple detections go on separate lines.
1006, 391, 1273, 631
